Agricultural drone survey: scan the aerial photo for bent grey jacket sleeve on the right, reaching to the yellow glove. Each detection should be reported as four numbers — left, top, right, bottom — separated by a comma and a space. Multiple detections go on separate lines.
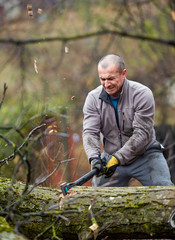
114, 88, 155, 165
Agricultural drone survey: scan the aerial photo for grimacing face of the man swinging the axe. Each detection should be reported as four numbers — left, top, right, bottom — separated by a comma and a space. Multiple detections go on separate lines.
98, 64, 126, 98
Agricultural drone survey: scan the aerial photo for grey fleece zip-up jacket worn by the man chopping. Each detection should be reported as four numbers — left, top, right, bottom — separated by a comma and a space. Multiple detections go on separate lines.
83, 78, 155, 165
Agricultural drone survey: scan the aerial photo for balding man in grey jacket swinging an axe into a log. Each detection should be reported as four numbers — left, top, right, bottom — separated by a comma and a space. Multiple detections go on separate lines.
83, 54, 173, 187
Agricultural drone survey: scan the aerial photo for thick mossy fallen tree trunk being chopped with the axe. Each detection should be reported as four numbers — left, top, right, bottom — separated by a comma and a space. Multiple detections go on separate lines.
0, 176, 175, 240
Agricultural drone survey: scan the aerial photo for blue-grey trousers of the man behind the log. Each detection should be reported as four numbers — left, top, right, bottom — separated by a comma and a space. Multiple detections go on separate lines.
92, 150, 174, 187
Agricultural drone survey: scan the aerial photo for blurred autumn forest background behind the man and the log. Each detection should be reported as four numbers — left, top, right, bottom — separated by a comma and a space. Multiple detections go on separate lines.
0, 0, 175, 187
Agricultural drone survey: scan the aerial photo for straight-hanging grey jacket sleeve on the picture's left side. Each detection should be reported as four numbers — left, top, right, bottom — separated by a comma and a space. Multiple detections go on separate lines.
83, 93, 100, 159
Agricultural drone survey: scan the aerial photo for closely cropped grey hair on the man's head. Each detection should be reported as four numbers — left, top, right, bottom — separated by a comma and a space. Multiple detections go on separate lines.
98, 54, 125, 73
